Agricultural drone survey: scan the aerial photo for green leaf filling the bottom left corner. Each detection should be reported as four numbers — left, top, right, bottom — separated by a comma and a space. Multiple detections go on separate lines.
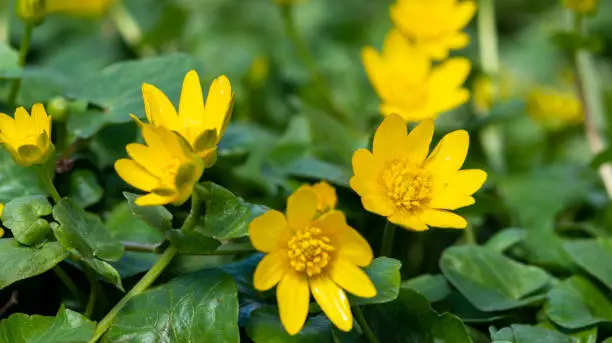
0, 305, 96, 343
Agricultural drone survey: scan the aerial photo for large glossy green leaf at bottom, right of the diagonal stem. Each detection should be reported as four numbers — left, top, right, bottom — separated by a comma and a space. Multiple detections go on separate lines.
103, 270, 240, 343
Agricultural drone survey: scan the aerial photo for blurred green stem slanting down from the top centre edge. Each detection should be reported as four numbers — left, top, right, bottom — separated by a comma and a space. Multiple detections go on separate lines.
279, 4, 350, 124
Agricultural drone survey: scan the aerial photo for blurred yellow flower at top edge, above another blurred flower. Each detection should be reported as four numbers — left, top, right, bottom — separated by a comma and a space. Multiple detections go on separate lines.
391, 0, 476, 60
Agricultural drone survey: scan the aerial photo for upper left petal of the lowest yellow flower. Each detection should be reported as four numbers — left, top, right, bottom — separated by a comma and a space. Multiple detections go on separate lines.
249, 210, 289, 252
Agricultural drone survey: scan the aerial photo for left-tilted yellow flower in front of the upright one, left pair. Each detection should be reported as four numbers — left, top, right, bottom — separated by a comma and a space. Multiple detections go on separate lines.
115, 124, 204, 206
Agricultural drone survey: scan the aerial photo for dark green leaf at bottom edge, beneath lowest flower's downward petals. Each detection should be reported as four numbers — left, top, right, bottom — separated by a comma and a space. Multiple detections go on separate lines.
246, 308, 333, 343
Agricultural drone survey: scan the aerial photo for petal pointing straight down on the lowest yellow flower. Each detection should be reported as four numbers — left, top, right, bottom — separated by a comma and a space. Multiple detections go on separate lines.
276, 271, 310, 335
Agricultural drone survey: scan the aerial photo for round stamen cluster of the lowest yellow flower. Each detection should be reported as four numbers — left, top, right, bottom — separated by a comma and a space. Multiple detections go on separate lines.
289, 227, 334, 276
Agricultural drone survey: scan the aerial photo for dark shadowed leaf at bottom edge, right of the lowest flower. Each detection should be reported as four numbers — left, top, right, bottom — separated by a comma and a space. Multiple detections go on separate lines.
363, 288, 472, 343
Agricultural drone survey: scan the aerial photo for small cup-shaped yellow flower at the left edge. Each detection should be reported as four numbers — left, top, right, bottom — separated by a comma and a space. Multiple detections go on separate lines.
0, 104, 55, 166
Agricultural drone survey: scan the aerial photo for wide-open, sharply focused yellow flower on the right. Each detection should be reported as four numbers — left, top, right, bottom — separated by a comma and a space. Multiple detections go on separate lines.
350, 115, 487, 231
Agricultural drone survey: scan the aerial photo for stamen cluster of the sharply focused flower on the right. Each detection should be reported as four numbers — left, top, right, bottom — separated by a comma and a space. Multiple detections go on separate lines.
381, 161, 433, 213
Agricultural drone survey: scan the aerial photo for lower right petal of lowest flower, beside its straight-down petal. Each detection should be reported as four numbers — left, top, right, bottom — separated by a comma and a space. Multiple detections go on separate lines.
310, 275, 353, 332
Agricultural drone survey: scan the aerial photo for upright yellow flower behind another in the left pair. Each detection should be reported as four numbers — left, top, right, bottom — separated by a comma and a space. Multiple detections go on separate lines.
132, 70, 234, 167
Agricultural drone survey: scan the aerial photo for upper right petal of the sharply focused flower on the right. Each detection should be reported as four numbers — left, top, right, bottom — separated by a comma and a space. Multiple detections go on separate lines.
425, 130, 470, 175
